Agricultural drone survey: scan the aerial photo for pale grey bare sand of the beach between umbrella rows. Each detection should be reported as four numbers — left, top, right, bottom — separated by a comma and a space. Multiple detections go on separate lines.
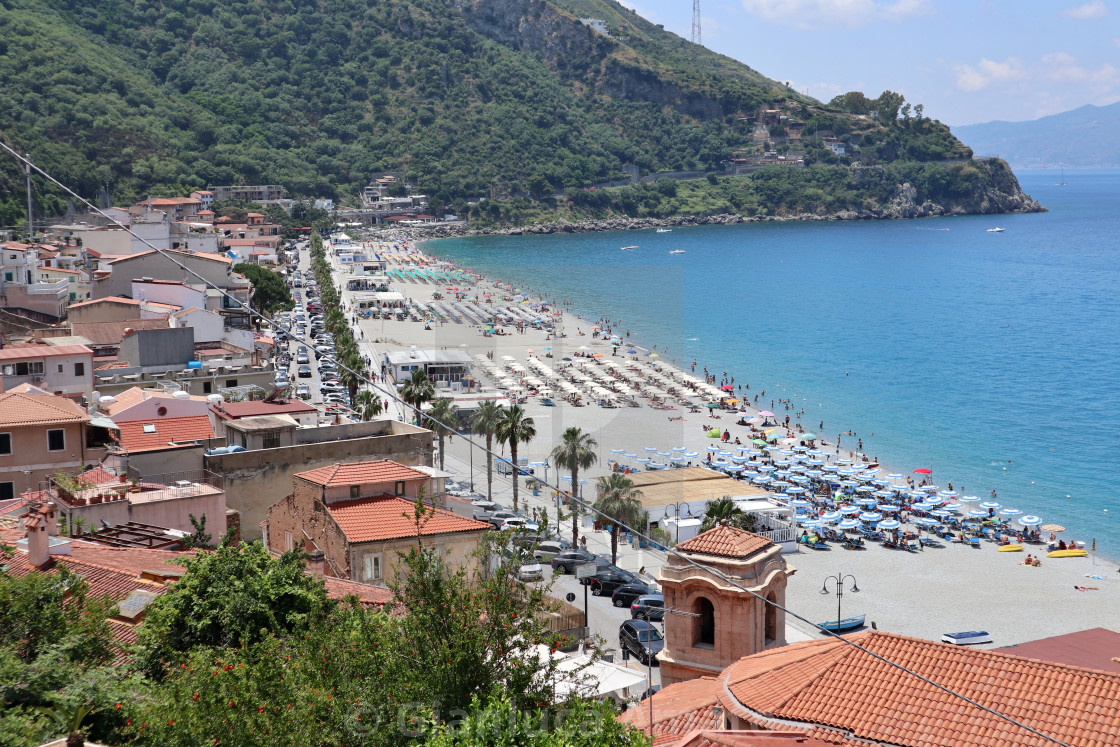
336, 232, 1120, 646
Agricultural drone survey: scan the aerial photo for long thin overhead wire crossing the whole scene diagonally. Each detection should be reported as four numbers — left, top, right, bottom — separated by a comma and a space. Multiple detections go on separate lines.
0, 140, 1070, 747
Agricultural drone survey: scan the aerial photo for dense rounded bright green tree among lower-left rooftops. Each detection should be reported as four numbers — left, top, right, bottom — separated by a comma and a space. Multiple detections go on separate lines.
138, 542, 334, 678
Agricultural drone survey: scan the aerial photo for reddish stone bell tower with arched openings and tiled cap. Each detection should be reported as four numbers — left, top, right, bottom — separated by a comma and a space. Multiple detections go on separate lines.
657, 524, 796, 687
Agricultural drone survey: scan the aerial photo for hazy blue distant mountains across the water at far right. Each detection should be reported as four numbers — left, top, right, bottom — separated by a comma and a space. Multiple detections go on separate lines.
953, 102, 1120, 168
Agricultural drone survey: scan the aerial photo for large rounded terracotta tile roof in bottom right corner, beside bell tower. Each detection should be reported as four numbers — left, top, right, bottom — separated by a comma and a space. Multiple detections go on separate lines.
719, 632, 1120, 747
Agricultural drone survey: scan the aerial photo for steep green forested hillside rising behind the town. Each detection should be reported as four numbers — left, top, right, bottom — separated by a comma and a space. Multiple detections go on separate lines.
0, 0, 994, 225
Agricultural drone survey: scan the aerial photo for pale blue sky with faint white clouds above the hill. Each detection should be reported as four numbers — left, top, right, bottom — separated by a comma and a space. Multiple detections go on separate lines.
622, 0, 1120, 125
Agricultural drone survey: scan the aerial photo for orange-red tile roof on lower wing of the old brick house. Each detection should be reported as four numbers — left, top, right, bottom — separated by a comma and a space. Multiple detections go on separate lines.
324, 497, 491, 542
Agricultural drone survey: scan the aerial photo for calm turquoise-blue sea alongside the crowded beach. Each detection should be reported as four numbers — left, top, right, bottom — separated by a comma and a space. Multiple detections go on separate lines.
429, 170, 1120, 559
